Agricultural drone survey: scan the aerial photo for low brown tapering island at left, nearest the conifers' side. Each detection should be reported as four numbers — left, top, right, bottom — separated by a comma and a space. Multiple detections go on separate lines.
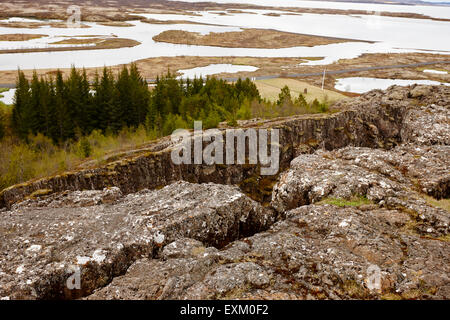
0, 38, 141, 54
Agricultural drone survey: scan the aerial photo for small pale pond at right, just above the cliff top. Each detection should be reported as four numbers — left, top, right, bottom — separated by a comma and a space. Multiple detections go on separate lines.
335, 77, 449, 93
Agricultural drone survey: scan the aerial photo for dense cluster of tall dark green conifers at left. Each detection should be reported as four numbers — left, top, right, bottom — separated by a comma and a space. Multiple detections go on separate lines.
11, 64, 150, 142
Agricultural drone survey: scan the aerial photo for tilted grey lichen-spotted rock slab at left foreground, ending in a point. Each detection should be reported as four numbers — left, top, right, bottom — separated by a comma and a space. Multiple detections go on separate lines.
0, 182, 275, 299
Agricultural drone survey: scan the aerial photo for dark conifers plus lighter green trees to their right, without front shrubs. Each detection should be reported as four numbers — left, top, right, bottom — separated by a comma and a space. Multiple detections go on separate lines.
8, 64, 260, 143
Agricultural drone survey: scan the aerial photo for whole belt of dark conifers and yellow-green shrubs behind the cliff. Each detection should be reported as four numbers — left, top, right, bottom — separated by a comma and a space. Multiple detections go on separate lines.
0, 64, 327, 190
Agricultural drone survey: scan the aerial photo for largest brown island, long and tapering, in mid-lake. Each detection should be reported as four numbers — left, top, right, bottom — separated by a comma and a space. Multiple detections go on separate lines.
153, 29, 368, 49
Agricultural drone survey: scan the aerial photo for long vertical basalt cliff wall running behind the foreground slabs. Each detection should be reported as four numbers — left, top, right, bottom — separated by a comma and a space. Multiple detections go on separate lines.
0, 86, 450, 208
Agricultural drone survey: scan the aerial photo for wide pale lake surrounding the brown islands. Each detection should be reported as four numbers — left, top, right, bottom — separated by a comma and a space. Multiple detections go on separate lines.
0, 0, 450, 72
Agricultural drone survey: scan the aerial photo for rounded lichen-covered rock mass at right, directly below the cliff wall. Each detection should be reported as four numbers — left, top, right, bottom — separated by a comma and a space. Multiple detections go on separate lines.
272, 145, 450, 237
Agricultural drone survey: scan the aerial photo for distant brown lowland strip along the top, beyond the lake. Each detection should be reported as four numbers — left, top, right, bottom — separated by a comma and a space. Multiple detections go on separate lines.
0, 0, 450, 22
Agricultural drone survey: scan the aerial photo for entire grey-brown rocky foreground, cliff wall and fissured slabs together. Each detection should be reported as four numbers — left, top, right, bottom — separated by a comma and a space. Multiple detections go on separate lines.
0, 86, 450, 299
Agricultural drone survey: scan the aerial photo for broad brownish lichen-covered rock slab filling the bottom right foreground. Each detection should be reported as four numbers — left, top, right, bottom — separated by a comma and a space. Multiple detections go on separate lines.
88, 205, 450, 299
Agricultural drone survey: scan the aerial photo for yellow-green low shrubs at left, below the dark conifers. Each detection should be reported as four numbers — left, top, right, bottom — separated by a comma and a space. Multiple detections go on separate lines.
0, 126, 153, 190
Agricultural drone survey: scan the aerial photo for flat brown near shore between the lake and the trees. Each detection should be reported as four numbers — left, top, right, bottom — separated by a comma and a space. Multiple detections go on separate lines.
0, 52, 450, 92
